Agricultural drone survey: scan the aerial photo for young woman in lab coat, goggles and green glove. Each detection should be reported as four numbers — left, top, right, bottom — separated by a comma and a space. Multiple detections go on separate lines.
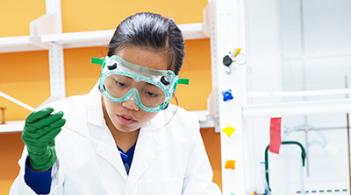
10, 13, 220, 195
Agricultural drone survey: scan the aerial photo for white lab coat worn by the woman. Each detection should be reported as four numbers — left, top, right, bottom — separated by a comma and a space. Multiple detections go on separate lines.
10, 86, 220, 195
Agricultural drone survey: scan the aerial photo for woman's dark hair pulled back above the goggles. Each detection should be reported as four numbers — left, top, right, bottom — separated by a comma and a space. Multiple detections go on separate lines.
108, 12, 184, 75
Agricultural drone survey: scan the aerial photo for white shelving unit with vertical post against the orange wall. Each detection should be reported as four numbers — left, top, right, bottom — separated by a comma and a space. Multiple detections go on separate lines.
0, 0, 214, 133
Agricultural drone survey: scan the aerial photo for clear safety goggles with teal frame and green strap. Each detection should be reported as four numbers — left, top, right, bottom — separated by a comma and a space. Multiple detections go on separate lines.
92, 55, 189, 112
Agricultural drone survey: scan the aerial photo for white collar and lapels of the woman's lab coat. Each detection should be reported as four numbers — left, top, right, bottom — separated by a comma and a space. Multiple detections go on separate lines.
87, 81, 165, 182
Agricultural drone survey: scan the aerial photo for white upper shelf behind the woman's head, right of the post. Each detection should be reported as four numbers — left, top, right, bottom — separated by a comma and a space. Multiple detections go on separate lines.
41, 23, 208, 48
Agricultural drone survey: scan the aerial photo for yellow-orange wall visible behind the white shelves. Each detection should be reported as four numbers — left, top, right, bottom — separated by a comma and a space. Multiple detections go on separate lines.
0, 0, 221, 194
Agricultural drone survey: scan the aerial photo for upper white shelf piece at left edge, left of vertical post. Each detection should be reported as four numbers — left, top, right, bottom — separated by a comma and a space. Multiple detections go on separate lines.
0, 36, 43, 53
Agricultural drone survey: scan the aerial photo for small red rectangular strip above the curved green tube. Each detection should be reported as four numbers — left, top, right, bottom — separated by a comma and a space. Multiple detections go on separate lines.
269, 117, 282, 154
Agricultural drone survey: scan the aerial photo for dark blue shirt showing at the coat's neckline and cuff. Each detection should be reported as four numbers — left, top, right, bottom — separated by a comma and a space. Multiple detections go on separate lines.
24, 144, 136, 194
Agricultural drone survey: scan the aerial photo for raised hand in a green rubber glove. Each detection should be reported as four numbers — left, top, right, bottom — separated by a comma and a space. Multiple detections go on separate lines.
22, 107, 66, 171
